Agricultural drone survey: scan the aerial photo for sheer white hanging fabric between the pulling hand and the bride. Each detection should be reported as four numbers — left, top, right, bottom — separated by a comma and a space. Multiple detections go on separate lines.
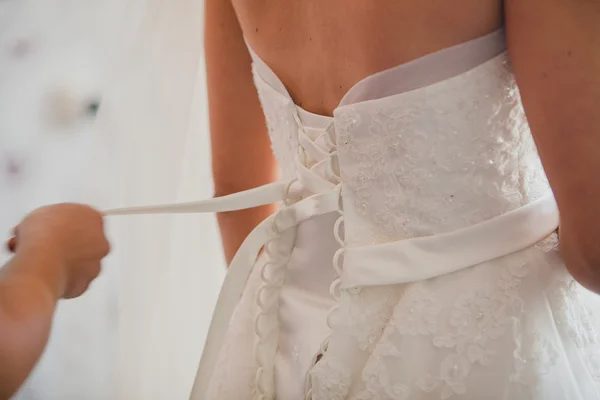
94, 0, 225, 399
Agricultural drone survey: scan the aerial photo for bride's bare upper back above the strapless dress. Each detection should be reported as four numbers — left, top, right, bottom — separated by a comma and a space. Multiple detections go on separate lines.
233, 0, 502, 114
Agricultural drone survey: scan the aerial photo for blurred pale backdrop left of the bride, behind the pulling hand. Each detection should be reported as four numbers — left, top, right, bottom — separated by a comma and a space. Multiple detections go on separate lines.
0, 0, 225, 400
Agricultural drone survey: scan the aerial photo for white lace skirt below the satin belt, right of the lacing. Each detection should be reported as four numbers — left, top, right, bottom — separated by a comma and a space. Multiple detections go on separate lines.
311, 248, 600, 400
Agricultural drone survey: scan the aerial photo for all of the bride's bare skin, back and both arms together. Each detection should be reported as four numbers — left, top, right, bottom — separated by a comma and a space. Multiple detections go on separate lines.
205, 0, 600, 292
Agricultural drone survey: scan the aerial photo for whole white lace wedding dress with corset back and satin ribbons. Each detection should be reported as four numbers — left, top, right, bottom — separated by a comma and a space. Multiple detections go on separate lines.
106, 31, 600, 400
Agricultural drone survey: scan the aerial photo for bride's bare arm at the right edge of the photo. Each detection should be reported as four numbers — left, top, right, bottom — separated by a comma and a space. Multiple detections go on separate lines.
505, 0, 600, 293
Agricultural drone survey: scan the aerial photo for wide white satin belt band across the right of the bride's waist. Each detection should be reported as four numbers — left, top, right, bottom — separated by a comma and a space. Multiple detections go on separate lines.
341, 192, 559, 289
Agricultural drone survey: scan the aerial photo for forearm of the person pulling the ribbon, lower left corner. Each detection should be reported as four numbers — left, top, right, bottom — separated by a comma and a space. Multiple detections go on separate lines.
0, 250, 63, 399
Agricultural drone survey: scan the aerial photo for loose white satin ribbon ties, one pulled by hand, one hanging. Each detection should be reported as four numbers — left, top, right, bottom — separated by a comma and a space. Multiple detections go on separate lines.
104, 182, 340, 400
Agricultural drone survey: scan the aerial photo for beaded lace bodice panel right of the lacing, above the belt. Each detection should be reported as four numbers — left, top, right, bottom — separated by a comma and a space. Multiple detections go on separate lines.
336, 54, 549, 245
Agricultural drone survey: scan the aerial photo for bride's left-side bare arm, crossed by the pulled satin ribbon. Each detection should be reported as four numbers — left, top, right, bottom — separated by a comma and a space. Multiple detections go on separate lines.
204, 0, 276, 263
